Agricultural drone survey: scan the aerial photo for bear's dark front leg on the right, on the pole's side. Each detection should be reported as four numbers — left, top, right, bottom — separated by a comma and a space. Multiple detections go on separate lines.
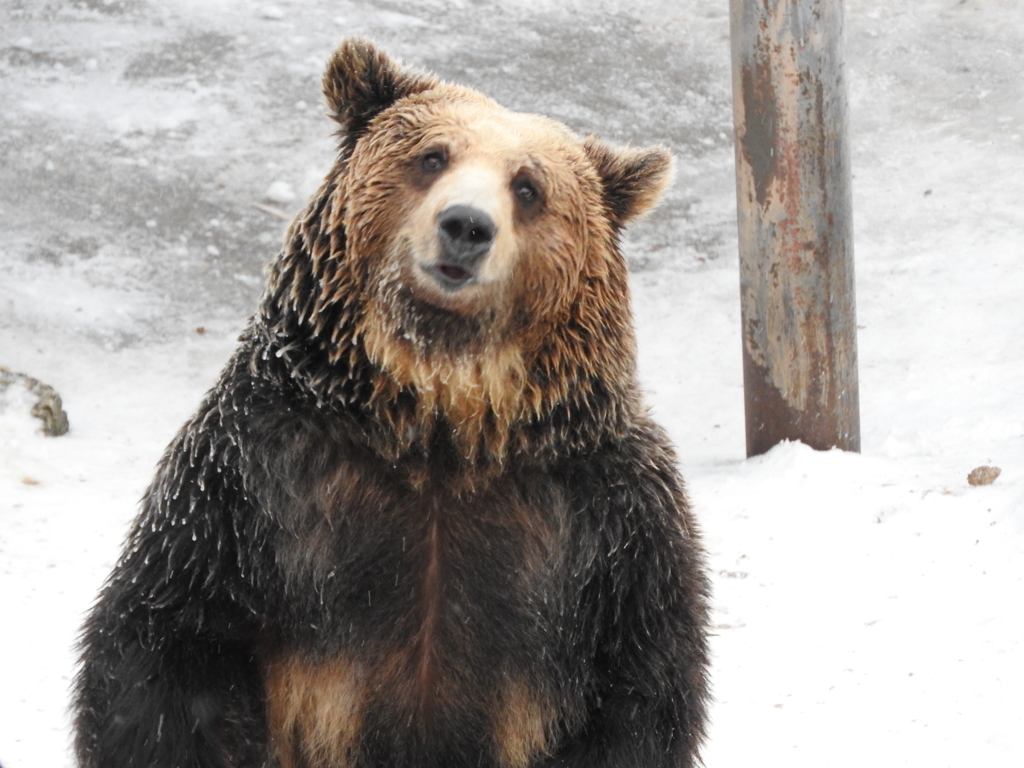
542, 442, 709, 768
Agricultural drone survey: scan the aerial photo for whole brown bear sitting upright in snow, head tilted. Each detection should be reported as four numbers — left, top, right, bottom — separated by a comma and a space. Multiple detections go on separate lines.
75, 40, 708, 768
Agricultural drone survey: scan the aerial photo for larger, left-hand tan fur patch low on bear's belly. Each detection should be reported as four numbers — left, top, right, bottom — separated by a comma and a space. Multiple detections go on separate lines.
266, 654, 367, 768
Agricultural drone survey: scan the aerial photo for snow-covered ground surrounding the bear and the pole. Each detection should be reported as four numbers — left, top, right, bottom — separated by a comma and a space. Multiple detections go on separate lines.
0, 0, 1024, 768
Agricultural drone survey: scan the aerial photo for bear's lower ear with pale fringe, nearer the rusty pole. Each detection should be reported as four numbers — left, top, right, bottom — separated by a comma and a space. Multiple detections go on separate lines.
583, 136, 676, 227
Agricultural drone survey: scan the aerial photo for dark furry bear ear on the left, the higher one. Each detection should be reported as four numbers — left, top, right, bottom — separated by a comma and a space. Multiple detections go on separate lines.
324, 38, 437, 150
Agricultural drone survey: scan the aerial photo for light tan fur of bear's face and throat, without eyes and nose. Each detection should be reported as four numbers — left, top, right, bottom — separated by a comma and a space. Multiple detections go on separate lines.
338, 99, 604, 466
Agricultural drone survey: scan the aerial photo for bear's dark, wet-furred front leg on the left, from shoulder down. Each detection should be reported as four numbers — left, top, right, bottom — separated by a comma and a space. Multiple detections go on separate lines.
74, 411, 276, 768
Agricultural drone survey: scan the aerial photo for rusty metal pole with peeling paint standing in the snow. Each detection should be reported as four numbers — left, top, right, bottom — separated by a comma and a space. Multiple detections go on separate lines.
730, 0, 860, 456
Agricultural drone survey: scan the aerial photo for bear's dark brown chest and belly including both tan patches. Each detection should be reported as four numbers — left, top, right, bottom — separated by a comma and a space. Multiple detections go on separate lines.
265, 454, 568, 765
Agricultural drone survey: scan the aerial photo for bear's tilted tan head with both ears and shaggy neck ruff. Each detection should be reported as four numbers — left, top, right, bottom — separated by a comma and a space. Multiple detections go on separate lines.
264, 40, 673, 463
